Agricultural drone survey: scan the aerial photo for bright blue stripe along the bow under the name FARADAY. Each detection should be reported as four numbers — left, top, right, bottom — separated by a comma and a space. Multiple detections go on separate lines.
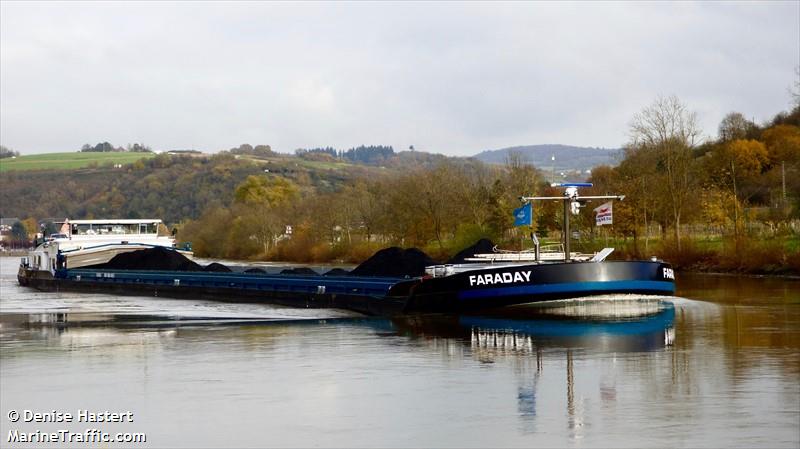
458, 281, 675, 299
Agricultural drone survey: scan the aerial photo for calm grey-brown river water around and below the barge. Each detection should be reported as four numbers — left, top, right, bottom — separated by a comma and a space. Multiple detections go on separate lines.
0, 258, 800, 447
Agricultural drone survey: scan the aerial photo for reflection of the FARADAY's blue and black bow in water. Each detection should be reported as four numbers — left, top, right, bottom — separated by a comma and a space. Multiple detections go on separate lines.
393, 298, 675, 439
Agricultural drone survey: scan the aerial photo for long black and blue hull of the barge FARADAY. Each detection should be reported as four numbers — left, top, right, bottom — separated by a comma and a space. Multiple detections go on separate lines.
18, 256, 674, 316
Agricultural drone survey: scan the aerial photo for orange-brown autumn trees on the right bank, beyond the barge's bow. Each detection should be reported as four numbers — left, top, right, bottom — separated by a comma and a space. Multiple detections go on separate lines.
592, 97, 800, 271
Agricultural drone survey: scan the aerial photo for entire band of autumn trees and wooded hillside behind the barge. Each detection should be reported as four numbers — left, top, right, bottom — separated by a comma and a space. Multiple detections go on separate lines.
0, 97, 800, 274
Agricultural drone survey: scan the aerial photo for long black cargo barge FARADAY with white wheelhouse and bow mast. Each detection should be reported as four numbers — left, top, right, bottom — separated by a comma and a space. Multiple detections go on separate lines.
17, 184, 675, 316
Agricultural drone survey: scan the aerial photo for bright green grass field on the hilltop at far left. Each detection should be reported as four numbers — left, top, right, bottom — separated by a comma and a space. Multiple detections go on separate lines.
0, 152, 154, 172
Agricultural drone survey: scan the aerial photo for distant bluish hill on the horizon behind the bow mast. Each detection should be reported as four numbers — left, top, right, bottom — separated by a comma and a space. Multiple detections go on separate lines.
474, 145, 622, 172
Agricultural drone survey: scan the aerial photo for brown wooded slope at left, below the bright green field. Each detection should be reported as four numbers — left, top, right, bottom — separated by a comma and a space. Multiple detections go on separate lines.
0, 153, 379, 224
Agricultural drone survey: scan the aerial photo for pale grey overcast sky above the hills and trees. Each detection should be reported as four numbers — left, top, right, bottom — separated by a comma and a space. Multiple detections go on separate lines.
0, 1, 800, 155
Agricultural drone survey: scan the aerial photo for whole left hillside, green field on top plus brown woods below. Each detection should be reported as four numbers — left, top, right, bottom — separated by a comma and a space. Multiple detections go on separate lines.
0, 145, 612, 223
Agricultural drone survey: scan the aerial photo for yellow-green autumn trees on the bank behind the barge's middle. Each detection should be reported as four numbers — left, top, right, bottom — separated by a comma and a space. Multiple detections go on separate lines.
179, 153, 542, 261
